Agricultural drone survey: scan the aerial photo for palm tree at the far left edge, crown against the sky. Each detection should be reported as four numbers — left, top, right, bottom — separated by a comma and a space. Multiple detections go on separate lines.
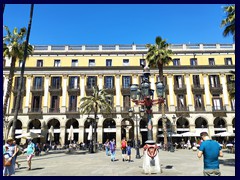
3, 26, 26, 122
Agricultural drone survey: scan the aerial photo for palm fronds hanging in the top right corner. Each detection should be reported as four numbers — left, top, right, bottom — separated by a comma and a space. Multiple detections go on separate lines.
221, 4, 235, 41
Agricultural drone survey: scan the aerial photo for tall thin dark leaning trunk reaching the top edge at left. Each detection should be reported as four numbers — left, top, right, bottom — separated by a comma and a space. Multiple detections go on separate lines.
11, 4, 34, 137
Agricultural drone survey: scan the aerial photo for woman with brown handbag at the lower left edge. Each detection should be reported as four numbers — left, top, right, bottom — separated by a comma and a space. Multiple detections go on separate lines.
3, 138, 17, 176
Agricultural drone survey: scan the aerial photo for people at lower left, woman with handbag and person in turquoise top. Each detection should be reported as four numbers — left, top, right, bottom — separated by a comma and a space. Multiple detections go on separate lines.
3, 138, 35, 176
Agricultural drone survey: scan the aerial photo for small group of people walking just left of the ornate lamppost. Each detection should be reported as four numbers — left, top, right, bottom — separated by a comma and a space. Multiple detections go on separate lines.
104, 137, 132, 162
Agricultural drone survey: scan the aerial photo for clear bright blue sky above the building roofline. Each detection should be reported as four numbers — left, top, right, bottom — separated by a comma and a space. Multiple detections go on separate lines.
3, 4, 233, 45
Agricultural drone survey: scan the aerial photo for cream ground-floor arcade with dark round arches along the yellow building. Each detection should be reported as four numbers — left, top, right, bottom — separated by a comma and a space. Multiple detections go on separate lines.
4, 113, 235, 147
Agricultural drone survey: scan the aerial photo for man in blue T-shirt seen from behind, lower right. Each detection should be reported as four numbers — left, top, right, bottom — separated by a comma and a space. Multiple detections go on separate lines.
197, 132, 223, 176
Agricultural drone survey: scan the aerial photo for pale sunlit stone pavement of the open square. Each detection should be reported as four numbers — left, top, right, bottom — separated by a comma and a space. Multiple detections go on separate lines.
14, 149, 235, 176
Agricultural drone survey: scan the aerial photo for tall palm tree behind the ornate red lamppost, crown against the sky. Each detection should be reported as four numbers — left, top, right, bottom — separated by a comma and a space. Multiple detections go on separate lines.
146, 36, 172, 147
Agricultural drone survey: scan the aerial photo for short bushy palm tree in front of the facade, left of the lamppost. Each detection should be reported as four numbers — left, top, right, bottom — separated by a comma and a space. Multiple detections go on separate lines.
80, 87, 112, 152
